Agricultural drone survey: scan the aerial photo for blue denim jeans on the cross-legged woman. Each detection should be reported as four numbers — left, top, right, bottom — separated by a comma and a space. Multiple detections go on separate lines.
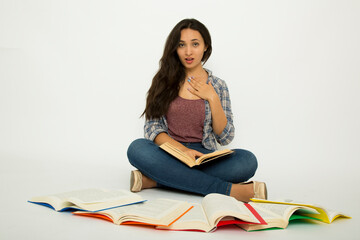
127, 138, 257, 195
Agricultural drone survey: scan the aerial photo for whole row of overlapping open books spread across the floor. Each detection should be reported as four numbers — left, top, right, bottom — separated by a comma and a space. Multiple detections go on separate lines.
29, 189, 350, 232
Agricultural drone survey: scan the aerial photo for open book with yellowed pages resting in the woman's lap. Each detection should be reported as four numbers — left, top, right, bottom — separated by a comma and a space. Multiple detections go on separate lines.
160, 142, 234, 167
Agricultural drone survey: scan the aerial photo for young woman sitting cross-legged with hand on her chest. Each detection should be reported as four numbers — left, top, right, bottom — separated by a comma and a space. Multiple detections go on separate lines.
128, 19, 267, 202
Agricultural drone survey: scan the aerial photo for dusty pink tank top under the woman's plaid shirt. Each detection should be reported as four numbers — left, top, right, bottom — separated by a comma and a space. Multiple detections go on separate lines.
166, 96, 205, 142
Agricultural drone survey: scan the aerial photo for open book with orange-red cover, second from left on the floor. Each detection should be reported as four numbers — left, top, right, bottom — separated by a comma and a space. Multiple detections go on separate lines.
74, 198, 192, 227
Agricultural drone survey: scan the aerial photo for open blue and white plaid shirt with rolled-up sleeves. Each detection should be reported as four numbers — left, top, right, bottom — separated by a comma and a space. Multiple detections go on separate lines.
144, 69, 235, 150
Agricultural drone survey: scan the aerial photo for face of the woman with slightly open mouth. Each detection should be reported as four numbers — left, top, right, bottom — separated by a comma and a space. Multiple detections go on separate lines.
177, 28, 206, 70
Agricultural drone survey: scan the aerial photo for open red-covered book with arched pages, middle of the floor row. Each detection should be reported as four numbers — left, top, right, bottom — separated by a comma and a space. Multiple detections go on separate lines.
157, 193, 266, 232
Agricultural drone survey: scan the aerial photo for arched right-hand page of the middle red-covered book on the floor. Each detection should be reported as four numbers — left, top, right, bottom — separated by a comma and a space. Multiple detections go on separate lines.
202, 193, 259, 226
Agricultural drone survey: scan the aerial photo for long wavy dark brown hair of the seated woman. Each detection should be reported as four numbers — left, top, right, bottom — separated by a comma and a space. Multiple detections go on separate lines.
141, 19, 212, 119
